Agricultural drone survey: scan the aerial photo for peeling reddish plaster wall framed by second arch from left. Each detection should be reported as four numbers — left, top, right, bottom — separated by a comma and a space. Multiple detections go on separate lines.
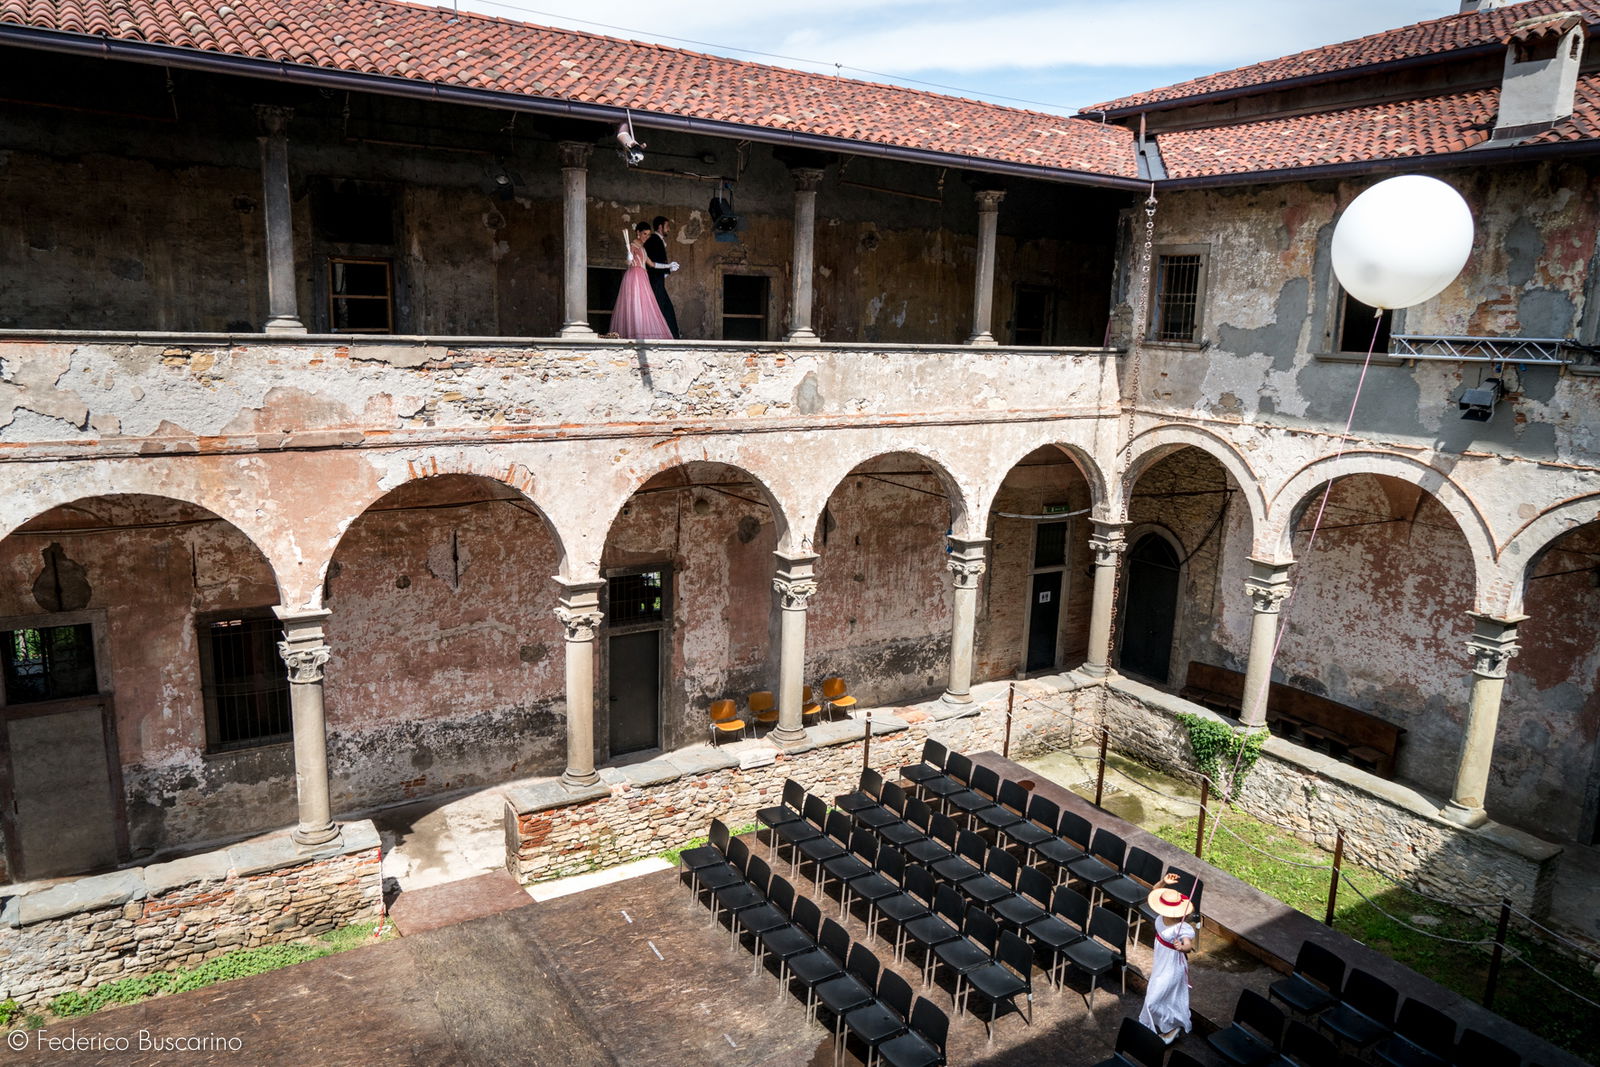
323, 477, 566, 809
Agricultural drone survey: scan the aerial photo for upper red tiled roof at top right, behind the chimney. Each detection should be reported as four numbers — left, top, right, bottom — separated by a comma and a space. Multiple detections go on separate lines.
1080, 0, 1600, 114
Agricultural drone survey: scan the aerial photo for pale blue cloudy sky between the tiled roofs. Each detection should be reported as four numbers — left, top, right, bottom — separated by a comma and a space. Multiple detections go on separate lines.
446, 0, 1461, 114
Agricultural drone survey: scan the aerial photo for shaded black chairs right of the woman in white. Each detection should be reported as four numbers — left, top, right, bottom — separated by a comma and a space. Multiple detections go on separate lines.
1260, 941, 1522, 1067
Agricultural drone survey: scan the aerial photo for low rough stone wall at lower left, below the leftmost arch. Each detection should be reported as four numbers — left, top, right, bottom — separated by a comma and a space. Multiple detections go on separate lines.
0, 822, 382, 1009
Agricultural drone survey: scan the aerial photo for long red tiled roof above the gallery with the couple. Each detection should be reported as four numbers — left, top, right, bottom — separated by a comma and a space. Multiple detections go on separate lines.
0, 0, 1136, 178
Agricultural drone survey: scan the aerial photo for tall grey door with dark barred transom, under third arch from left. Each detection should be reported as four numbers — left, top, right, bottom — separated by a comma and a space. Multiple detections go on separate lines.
605, 566, 670, 757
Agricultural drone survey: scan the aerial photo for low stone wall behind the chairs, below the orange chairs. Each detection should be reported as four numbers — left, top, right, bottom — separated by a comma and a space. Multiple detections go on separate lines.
506, 677, 1094, 881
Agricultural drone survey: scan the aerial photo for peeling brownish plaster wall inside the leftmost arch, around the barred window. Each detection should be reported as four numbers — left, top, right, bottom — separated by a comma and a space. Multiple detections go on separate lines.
0, 496, 284, 854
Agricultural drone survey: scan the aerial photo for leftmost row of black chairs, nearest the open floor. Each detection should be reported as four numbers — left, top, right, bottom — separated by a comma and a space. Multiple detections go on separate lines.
680, 819, 950, 1067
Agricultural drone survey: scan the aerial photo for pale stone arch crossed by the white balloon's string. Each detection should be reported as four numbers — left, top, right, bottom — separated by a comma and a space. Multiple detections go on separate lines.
1258, 451, 1498, 611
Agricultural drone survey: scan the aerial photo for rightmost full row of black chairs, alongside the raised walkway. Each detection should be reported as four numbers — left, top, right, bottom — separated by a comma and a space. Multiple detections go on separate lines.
902, 748, 1205, 937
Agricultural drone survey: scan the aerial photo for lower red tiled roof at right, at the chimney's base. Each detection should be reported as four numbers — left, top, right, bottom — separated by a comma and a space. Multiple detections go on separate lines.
1157, 74, 1600, 178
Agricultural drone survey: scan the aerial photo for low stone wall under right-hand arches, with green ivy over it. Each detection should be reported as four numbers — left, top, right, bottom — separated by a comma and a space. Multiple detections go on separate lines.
1102, 680, 1562, 915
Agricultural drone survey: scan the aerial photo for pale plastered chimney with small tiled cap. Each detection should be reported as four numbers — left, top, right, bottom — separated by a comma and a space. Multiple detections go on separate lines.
1494, 11, 1586, 141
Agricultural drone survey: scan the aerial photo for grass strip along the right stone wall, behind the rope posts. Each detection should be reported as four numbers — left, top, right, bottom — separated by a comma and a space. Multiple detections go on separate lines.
1150, 811, 1600, 1059
